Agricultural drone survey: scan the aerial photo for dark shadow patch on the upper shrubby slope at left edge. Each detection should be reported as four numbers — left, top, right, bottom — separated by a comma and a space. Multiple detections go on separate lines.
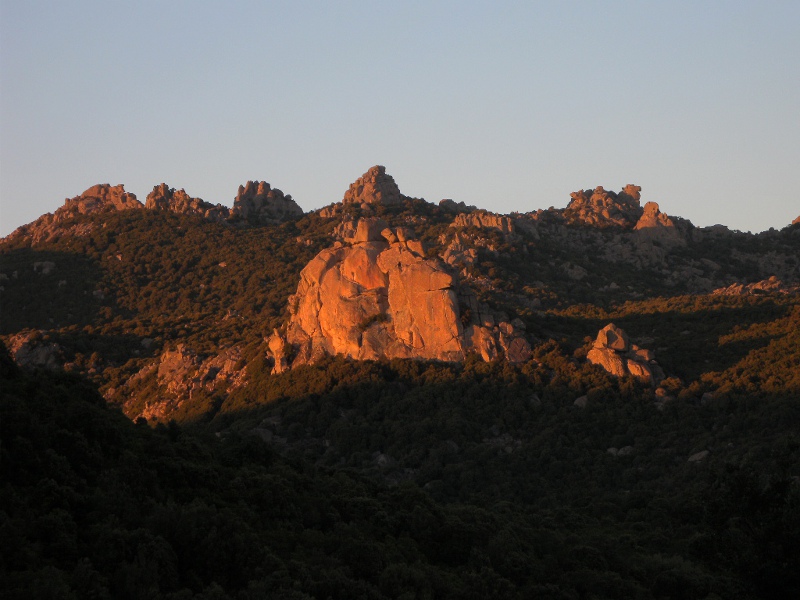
0, 248, 113, 334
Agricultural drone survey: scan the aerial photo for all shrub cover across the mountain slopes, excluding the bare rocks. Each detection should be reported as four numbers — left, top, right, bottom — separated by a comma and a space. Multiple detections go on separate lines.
0, 200, 800, 599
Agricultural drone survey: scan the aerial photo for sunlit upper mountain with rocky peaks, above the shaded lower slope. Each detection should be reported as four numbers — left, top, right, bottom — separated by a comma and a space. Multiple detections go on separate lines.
0, 166, 800, 420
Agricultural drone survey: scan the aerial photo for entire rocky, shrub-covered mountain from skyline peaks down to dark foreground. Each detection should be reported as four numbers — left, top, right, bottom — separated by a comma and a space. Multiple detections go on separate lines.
0, 166, 800, 600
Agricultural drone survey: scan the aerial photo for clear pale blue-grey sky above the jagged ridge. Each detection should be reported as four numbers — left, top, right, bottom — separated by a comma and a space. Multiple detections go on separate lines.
0, 0, 800, 236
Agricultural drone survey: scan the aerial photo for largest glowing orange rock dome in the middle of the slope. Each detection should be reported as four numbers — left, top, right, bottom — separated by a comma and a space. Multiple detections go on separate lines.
268, 218, 530, 372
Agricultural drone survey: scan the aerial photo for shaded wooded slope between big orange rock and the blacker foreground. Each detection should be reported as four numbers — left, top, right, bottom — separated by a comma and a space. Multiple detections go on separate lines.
164, 352, 800, 518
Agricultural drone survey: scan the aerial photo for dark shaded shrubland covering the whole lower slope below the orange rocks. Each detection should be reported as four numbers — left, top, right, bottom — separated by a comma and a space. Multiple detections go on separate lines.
0, 344, 800, 598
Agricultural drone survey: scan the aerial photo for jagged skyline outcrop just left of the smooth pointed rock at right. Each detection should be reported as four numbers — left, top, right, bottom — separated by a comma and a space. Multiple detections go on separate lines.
564, 184, 644, 229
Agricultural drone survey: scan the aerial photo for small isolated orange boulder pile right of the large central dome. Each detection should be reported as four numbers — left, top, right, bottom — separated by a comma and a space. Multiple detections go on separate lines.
586, 323, 664, 384
